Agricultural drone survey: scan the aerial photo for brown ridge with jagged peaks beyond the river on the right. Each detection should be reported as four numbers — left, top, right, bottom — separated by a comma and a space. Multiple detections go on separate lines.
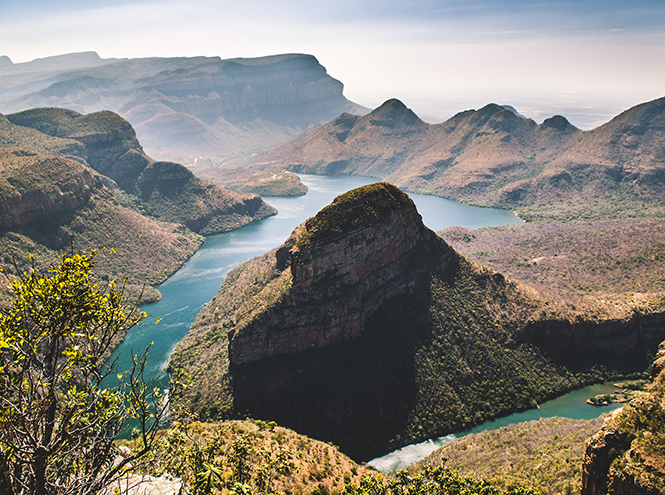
240, 98, 665, 220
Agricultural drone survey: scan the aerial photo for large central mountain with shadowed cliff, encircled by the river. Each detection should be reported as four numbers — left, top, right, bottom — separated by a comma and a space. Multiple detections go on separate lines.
169, 183, 663, 459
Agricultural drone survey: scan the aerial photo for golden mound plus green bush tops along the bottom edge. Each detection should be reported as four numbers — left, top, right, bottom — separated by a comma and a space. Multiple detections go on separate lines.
126, 420, 538, 495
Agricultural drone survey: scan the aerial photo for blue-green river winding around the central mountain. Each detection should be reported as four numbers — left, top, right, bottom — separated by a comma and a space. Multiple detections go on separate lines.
105, 175, 616, 462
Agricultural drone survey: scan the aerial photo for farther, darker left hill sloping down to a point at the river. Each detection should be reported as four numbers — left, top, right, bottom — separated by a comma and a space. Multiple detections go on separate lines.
0, 108, 275, 235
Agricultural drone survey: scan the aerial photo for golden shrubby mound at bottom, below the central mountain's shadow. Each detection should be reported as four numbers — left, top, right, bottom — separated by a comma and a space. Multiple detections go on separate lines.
137, 420, 370, 495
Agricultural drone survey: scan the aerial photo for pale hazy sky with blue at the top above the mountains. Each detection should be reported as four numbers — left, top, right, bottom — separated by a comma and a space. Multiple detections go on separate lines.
0, 0, 665, 129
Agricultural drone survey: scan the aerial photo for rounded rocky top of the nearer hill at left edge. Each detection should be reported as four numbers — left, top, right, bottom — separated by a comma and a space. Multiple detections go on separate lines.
0, 148, 102, 229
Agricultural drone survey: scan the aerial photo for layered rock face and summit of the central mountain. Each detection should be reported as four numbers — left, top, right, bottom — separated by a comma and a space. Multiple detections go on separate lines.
229, 183, 446, 365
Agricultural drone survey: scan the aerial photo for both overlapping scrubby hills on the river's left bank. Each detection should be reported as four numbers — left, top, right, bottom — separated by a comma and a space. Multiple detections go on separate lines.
0, 108, 276, 302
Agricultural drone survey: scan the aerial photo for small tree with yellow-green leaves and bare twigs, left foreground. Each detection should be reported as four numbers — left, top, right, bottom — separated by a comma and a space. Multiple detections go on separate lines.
0, 251, 179, 495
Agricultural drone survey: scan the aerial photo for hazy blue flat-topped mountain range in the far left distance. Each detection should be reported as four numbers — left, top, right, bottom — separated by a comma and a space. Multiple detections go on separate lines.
0, 52, 367, 165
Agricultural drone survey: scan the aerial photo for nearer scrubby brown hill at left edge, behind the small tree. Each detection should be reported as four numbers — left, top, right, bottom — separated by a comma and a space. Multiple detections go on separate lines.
0, 149, 202, 304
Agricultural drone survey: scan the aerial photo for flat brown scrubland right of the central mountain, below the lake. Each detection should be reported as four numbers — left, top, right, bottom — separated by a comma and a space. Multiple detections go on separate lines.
439, 218, 665, 319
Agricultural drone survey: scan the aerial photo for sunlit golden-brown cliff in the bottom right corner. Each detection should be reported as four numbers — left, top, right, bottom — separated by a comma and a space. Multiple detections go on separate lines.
582, 342, 665, 495
